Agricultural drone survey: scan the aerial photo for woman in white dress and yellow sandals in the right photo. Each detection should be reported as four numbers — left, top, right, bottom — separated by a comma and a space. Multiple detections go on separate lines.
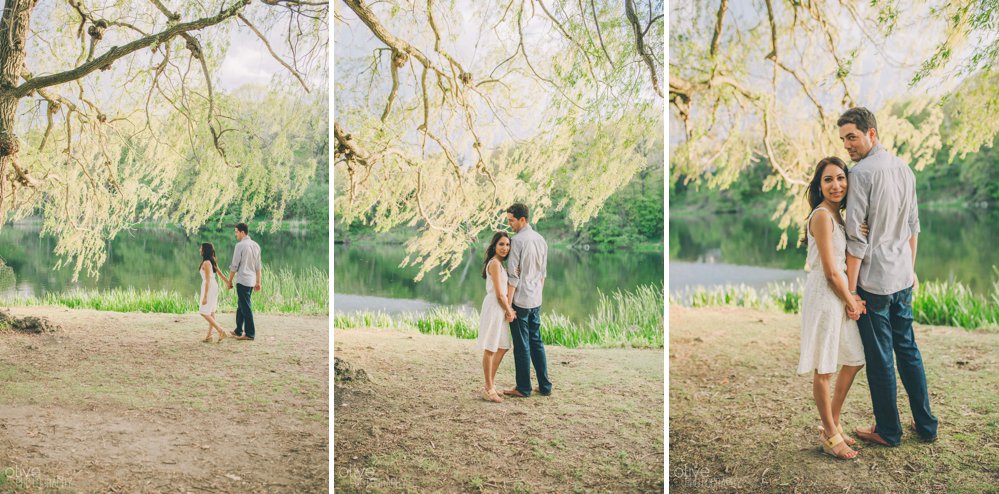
798, 157, 866, 460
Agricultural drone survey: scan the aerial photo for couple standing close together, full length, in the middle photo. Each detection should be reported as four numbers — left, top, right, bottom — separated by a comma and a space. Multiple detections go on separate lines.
476, 203, 552, 403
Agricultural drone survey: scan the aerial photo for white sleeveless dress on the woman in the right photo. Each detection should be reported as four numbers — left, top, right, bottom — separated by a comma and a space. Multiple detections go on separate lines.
798, 207, 864, 374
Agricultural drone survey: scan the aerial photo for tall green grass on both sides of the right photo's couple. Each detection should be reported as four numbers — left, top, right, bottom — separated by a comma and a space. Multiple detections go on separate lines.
670, 267, 999, 332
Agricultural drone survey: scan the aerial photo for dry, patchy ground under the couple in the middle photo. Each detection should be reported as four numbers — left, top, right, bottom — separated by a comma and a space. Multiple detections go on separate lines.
333, 329, 664, 493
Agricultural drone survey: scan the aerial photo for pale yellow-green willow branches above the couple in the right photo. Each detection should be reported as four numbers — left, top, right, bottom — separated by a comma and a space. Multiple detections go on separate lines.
669, 0, 999, 248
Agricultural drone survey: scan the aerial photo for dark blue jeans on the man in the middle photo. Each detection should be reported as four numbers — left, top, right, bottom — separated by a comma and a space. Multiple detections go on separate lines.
510, 305, 552, 396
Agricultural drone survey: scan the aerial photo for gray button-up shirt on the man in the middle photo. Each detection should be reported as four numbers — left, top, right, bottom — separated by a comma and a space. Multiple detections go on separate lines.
507, 225, 548, 309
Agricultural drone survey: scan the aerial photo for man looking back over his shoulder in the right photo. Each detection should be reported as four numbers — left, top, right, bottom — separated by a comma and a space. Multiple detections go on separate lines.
837, 108, 937, 446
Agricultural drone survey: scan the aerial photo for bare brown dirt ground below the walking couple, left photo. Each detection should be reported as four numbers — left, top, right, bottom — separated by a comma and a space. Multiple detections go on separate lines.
0, 307, 329, 493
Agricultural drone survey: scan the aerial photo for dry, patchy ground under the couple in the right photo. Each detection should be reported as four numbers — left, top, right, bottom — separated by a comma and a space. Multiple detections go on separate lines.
669, 307, 999, 493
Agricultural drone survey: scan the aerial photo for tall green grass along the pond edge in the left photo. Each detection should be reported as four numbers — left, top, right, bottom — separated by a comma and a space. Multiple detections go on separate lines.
2, 268, 329, 314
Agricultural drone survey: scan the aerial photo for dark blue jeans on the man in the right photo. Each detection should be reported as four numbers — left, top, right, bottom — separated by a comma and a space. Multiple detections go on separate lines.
857, 287, 937, 446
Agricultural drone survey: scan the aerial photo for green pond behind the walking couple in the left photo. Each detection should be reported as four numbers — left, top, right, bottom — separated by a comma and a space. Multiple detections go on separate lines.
0, 224, 329, 296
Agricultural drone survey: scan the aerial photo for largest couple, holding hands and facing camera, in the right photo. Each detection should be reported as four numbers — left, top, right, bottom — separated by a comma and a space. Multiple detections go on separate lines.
798, 108, 937, 459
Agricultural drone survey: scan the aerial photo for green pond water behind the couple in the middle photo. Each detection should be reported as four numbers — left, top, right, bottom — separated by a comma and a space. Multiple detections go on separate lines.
333, 245, 664, 323
